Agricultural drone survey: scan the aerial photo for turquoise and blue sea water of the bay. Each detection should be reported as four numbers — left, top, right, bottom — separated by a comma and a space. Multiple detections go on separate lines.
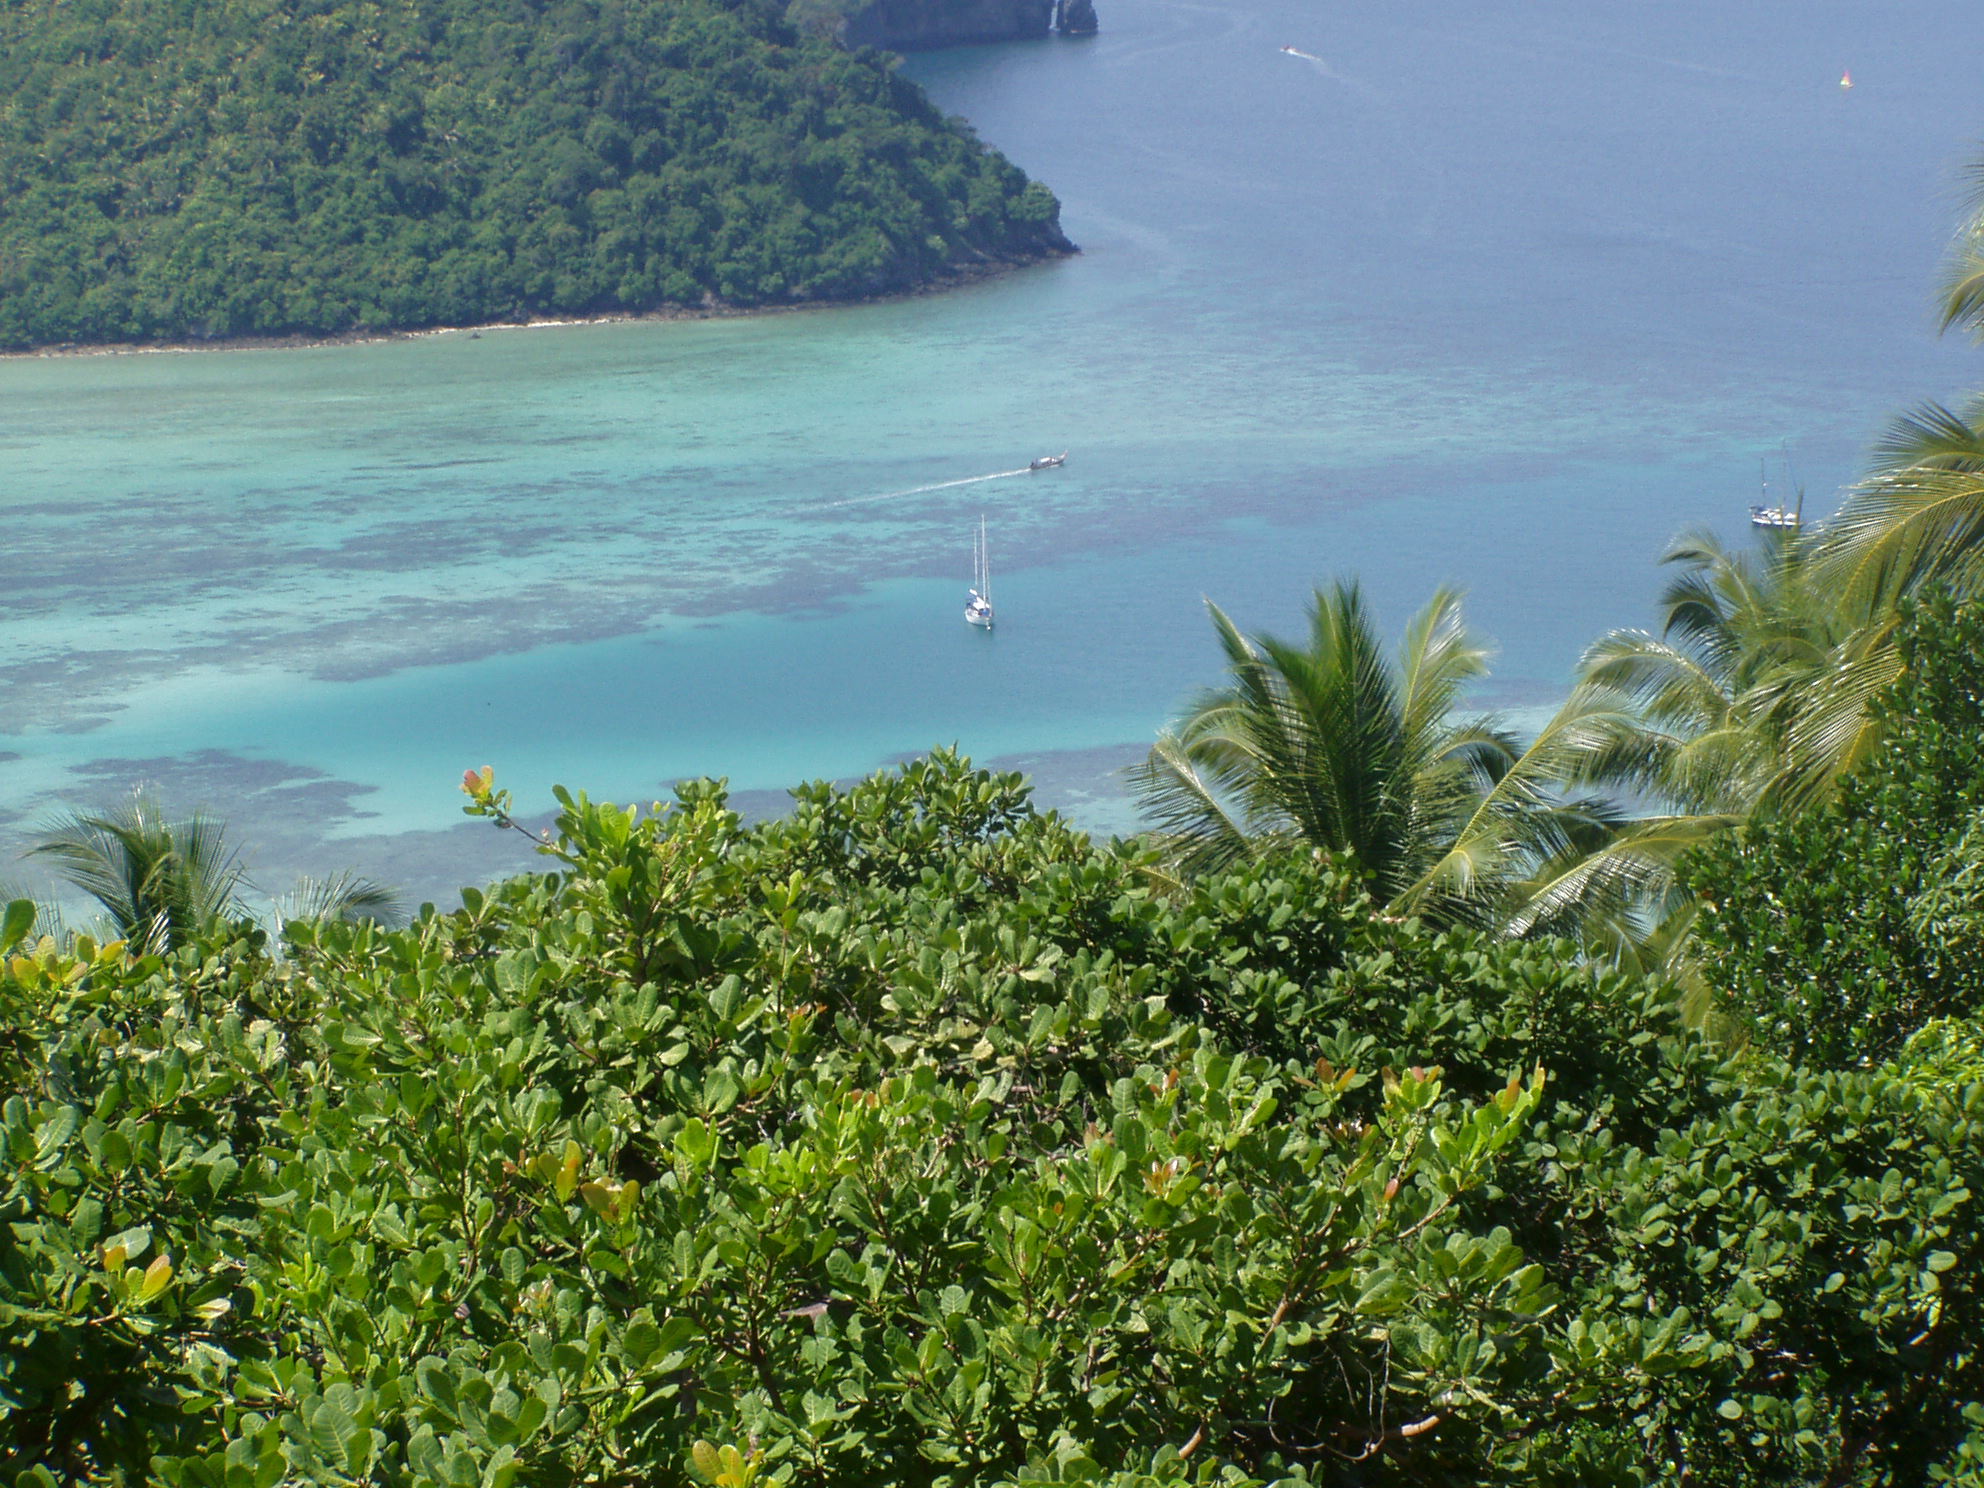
0, 0, 1984, 895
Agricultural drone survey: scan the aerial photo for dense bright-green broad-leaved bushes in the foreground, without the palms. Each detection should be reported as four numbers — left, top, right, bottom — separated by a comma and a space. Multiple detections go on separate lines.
11, 607, 1984, 1488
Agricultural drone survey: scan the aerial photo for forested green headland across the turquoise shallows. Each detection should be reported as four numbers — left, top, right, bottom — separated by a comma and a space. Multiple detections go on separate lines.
0, 0, 1069, 347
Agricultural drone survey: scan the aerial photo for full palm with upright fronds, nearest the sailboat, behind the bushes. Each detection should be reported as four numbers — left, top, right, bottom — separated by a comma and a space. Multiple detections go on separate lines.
1129, 583, 1629, 923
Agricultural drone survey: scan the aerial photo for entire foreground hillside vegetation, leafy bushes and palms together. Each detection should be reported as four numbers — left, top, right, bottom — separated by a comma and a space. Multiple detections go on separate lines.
11, 14, 1984, 1488
